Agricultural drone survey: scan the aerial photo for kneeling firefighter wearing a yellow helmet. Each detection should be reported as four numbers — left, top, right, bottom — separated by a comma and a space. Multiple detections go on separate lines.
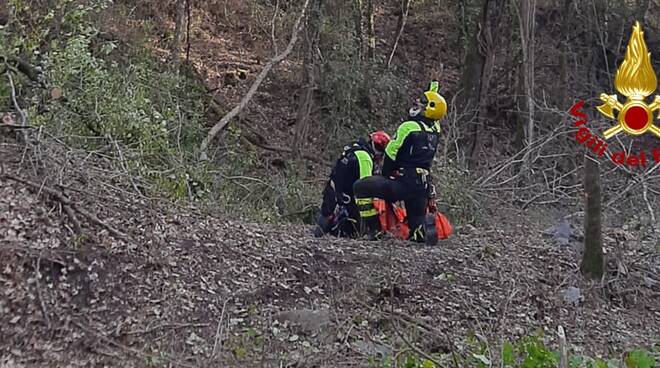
353, 81, 447, 245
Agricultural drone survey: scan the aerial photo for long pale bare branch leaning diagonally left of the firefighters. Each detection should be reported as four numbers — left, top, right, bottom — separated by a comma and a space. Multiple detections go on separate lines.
200, 0, 309, 161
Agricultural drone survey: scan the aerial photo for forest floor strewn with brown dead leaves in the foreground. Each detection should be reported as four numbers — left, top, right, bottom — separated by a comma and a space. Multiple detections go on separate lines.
0, 136, 660, 367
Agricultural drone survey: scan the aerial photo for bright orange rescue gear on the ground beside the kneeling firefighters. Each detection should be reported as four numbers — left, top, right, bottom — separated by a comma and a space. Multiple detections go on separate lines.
374, 198, 453, 240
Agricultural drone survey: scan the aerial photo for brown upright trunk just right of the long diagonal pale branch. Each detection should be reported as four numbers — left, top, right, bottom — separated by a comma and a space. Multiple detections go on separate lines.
291, 0, 321, 159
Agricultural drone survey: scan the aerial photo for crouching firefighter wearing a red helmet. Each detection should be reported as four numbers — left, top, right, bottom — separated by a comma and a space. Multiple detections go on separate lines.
314, 131, 390, 237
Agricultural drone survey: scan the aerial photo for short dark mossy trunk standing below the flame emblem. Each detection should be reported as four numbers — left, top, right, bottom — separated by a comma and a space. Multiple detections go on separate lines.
580, 154, 603, 279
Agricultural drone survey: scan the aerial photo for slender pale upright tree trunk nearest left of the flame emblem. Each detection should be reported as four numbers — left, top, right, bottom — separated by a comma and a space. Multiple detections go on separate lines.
520, 0, 536, 157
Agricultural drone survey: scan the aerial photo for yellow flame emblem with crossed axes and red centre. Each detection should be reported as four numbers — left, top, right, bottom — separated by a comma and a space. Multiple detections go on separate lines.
597, 22, 660, 139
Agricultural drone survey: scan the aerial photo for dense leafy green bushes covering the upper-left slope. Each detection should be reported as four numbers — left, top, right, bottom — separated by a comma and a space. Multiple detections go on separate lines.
0, 0, 209, 199
